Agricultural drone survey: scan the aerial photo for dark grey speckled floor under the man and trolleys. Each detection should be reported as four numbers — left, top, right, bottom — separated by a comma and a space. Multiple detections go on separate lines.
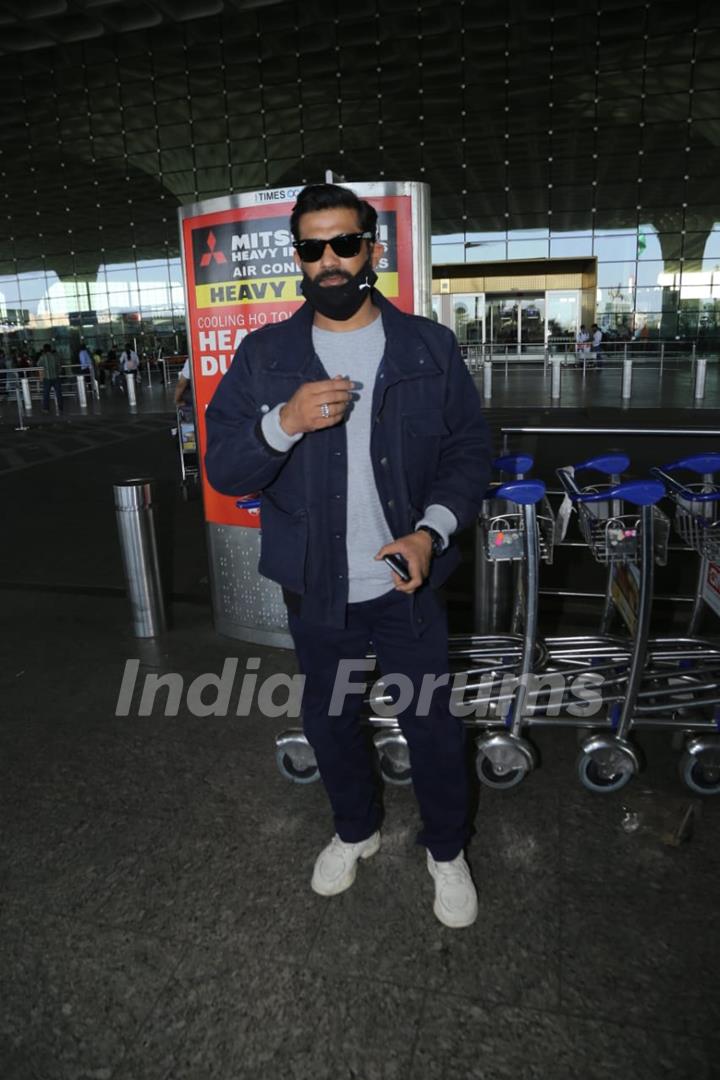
0, 380, 720, 1080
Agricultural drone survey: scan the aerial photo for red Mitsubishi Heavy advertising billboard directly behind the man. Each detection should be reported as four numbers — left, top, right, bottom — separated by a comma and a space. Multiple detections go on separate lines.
178, 181, 432, 646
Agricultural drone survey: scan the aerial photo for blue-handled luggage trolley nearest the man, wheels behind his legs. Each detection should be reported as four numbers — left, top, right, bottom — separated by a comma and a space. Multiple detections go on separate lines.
275, 473, 555, 787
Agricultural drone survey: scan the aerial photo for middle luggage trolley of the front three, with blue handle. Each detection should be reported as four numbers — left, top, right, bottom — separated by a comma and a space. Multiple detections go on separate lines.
548, 459, 669, 793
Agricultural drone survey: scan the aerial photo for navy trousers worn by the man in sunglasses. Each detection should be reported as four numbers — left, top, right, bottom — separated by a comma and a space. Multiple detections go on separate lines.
288, 590, 467, 861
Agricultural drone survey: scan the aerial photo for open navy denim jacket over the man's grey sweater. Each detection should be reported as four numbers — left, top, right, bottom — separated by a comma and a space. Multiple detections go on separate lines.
205, 291, 491, 634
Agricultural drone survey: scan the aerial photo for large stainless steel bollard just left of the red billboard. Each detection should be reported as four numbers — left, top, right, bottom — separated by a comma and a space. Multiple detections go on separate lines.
112, 478, 166, 637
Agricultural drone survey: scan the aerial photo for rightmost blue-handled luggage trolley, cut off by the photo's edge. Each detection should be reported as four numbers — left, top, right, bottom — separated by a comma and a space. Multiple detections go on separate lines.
652, 453, 720, 795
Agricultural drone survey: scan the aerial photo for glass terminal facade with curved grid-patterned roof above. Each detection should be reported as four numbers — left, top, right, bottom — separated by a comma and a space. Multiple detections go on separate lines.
0, 0, 720, 353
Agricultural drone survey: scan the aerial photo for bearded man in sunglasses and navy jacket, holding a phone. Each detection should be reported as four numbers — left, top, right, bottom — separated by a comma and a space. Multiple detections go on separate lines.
205, 185, 490, 927
